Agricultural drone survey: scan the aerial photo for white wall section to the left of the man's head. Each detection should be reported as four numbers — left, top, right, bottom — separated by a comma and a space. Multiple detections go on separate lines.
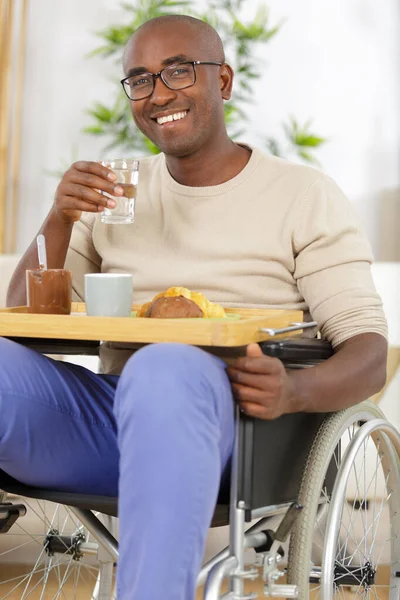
18, 0, 123, 251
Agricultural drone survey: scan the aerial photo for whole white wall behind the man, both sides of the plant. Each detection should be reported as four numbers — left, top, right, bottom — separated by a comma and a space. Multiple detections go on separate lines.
18, 0, 400, 251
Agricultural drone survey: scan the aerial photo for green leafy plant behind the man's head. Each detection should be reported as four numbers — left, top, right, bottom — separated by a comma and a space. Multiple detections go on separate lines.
84, 0, 326, 163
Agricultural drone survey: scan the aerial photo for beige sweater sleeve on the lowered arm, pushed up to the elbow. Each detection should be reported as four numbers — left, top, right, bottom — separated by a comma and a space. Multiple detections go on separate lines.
293, 176, 387, 347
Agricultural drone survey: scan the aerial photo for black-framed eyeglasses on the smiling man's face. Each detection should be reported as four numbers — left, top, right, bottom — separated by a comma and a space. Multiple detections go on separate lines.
121, 60, 223, 100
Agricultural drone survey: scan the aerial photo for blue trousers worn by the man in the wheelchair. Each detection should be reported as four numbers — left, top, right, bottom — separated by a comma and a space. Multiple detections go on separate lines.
0, 338, 234, 600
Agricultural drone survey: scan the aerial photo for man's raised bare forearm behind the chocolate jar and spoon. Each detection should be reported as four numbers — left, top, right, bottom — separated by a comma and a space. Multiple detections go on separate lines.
7, 210, 73, 306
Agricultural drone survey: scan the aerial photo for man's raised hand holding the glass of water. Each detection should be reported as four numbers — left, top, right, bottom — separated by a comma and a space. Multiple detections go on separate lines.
53, 161, 123, 223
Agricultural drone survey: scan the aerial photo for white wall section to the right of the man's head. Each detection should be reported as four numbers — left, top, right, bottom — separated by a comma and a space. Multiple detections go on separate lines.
250, 0, 400, 248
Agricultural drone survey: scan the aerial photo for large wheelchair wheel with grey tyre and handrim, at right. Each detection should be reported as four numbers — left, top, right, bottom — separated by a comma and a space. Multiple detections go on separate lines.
288, 402, 400, 600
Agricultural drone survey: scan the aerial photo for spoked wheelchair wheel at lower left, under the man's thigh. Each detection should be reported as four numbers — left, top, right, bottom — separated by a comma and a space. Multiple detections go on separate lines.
0, 494, 116, 600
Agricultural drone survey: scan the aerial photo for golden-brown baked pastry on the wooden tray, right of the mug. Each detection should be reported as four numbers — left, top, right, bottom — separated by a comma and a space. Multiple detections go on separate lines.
137, 287, 226, 319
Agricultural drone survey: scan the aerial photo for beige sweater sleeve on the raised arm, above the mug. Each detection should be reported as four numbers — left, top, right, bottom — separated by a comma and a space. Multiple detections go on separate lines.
65, 213, 101, 302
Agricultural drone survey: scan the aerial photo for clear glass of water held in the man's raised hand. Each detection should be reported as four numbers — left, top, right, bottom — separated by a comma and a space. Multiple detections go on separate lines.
100, 158, 139, 225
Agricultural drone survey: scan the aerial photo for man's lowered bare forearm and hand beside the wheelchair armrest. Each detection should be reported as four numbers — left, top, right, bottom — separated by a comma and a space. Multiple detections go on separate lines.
227, 333, 387, 419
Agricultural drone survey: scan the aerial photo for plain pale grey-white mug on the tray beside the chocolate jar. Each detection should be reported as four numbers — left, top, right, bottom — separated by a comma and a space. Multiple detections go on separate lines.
85, 273, 133, 317
